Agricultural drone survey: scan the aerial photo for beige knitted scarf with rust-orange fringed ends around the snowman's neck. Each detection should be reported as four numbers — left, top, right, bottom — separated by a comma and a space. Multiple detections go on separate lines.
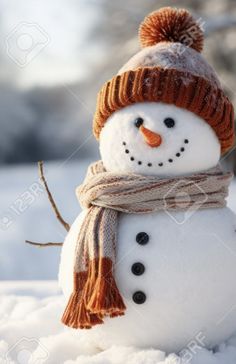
62, 161, 232, 329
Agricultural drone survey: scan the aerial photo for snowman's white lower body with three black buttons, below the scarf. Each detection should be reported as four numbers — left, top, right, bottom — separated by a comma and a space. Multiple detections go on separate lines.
59, 208, 236, 352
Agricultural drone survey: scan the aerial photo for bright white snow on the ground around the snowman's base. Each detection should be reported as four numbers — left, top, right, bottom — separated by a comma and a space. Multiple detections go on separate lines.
0, 281, 236, 364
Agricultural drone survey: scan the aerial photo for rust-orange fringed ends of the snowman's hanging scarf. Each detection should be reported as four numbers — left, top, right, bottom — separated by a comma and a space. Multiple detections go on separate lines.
62, 257, 126, 329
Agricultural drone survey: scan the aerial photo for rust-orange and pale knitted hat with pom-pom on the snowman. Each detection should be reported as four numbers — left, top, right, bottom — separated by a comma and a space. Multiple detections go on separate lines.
93, 7, 234, 153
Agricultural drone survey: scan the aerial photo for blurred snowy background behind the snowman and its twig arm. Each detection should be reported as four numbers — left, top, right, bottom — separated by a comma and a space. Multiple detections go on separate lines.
0, 0, 236, 280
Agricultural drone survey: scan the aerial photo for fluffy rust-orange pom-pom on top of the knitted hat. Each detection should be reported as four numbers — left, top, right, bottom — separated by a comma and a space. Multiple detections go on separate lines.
139, 7, 204, 52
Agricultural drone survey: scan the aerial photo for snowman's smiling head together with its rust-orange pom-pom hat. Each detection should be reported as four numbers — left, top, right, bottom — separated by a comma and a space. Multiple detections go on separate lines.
94, 8, 234, 176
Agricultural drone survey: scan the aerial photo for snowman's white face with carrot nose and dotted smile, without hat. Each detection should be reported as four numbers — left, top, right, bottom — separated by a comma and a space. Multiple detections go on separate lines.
100, 102, 221, 176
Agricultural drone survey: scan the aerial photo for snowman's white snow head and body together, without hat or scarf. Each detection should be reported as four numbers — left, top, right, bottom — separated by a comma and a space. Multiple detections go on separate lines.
59, 102, 236, 352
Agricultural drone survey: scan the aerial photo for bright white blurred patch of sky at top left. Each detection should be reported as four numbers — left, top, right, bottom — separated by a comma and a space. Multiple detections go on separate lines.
0, 0, 102, 87
